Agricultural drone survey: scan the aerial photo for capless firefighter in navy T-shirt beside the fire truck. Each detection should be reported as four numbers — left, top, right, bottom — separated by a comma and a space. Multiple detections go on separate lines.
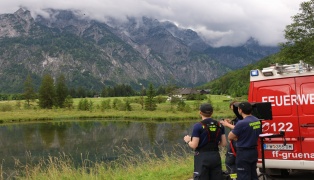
228, 102, 261, 180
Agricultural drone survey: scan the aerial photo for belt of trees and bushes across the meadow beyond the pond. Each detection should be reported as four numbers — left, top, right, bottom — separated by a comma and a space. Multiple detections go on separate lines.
0, 74, 201, 112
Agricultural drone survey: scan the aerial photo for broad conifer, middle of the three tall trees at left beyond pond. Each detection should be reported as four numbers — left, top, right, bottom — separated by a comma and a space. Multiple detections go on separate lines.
39, 74, 55, 108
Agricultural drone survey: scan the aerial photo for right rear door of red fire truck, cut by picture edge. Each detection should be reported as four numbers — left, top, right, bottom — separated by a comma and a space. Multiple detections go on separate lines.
296, 76, 314, 160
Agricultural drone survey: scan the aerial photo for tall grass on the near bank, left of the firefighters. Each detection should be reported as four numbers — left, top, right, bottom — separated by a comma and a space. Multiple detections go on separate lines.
12, 145, 197, 180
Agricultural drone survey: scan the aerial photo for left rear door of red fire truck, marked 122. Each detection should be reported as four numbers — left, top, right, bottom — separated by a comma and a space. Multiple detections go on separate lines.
249, 78, 300, 159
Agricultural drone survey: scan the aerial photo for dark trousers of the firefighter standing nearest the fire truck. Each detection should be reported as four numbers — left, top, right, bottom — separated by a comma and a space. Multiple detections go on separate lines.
236, 148, 258, 180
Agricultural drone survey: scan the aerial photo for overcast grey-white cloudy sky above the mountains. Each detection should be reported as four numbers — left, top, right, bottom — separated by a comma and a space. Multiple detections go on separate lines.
0, 0, 306, 46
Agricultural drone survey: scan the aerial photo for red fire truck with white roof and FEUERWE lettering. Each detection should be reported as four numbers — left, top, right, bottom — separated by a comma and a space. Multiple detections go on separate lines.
248, 61, 314, 175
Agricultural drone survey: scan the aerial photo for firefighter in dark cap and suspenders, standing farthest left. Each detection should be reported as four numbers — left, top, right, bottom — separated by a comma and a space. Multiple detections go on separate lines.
183, 103, 227, 180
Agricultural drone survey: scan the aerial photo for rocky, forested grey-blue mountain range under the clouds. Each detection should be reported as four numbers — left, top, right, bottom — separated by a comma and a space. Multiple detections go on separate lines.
0, 8, 279, 93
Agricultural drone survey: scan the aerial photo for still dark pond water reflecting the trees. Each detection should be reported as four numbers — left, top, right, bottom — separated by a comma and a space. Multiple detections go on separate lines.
0, 120, 195, 170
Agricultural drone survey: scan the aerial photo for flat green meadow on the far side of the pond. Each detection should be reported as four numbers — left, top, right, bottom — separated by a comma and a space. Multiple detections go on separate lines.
0, 95, 245, 123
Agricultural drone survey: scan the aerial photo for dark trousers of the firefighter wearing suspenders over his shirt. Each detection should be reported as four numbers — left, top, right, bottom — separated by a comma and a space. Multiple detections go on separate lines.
193, 151, 222, 180
